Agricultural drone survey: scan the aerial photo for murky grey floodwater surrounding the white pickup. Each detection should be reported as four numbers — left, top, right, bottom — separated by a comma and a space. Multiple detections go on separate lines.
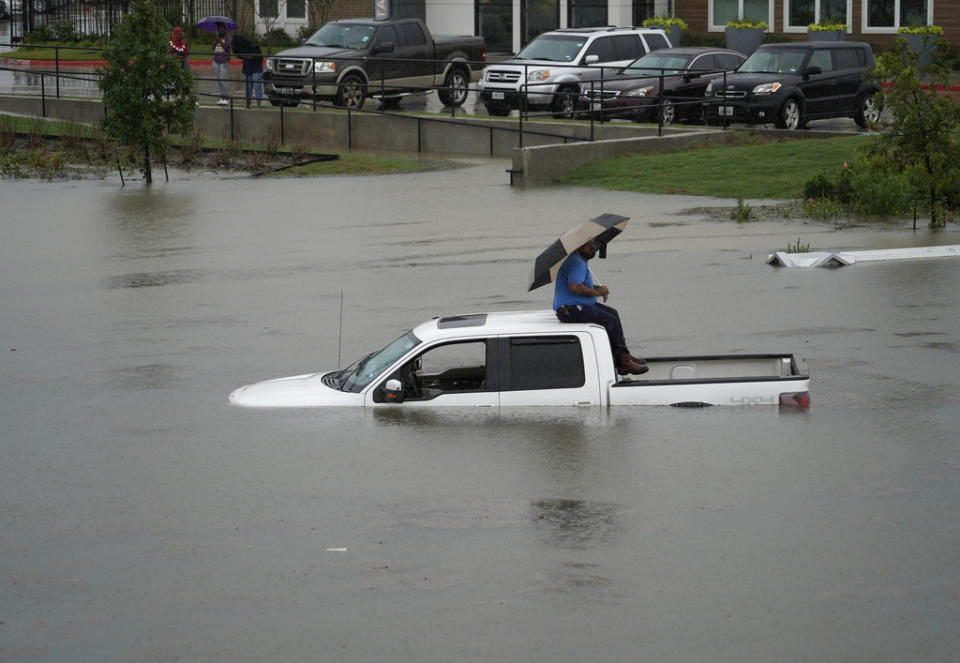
0, 161, 960, 663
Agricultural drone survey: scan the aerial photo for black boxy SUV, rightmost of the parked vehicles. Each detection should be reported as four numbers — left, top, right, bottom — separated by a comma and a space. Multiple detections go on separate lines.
704, 41, 880, 129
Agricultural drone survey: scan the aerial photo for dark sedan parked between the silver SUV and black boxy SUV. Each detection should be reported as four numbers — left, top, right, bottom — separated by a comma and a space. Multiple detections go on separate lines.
583, 47, 747, 124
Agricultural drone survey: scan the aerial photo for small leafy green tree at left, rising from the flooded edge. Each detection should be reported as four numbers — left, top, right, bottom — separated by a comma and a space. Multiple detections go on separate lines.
100, 0, 197, 184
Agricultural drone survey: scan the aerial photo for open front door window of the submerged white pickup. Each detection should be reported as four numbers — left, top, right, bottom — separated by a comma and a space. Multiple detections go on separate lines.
399, 340, 487, 400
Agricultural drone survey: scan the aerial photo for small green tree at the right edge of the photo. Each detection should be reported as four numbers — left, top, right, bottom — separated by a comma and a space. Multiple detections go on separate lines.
864, 38, 960, 227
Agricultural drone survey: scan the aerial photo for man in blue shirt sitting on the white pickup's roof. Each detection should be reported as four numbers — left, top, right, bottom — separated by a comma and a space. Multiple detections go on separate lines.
553, 239, 649, 375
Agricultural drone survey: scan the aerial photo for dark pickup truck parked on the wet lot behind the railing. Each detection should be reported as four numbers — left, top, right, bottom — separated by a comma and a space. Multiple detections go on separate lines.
263, 18, 486, 108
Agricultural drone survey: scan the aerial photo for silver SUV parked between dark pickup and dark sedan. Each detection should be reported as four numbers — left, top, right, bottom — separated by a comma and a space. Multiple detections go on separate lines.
477, 27, 671, 117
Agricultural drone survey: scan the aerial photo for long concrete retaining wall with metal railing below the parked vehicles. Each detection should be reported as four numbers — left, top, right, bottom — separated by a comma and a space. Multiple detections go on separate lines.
0, 95, 848, 185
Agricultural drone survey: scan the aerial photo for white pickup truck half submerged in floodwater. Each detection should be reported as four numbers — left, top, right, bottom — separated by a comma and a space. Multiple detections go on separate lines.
229, 310, 810, 407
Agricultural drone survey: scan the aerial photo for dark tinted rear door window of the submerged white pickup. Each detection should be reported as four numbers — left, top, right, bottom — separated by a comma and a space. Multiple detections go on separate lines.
509, 336, 586, 390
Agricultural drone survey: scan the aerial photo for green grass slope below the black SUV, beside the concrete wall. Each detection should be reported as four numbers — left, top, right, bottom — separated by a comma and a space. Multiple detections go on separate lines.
559, 135, 870, 200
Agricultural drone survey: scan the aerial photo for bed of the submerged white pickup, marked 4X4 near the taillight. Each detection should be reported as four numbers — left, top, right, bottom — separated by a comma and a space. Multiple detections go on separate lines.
610, 354, 810, 407
